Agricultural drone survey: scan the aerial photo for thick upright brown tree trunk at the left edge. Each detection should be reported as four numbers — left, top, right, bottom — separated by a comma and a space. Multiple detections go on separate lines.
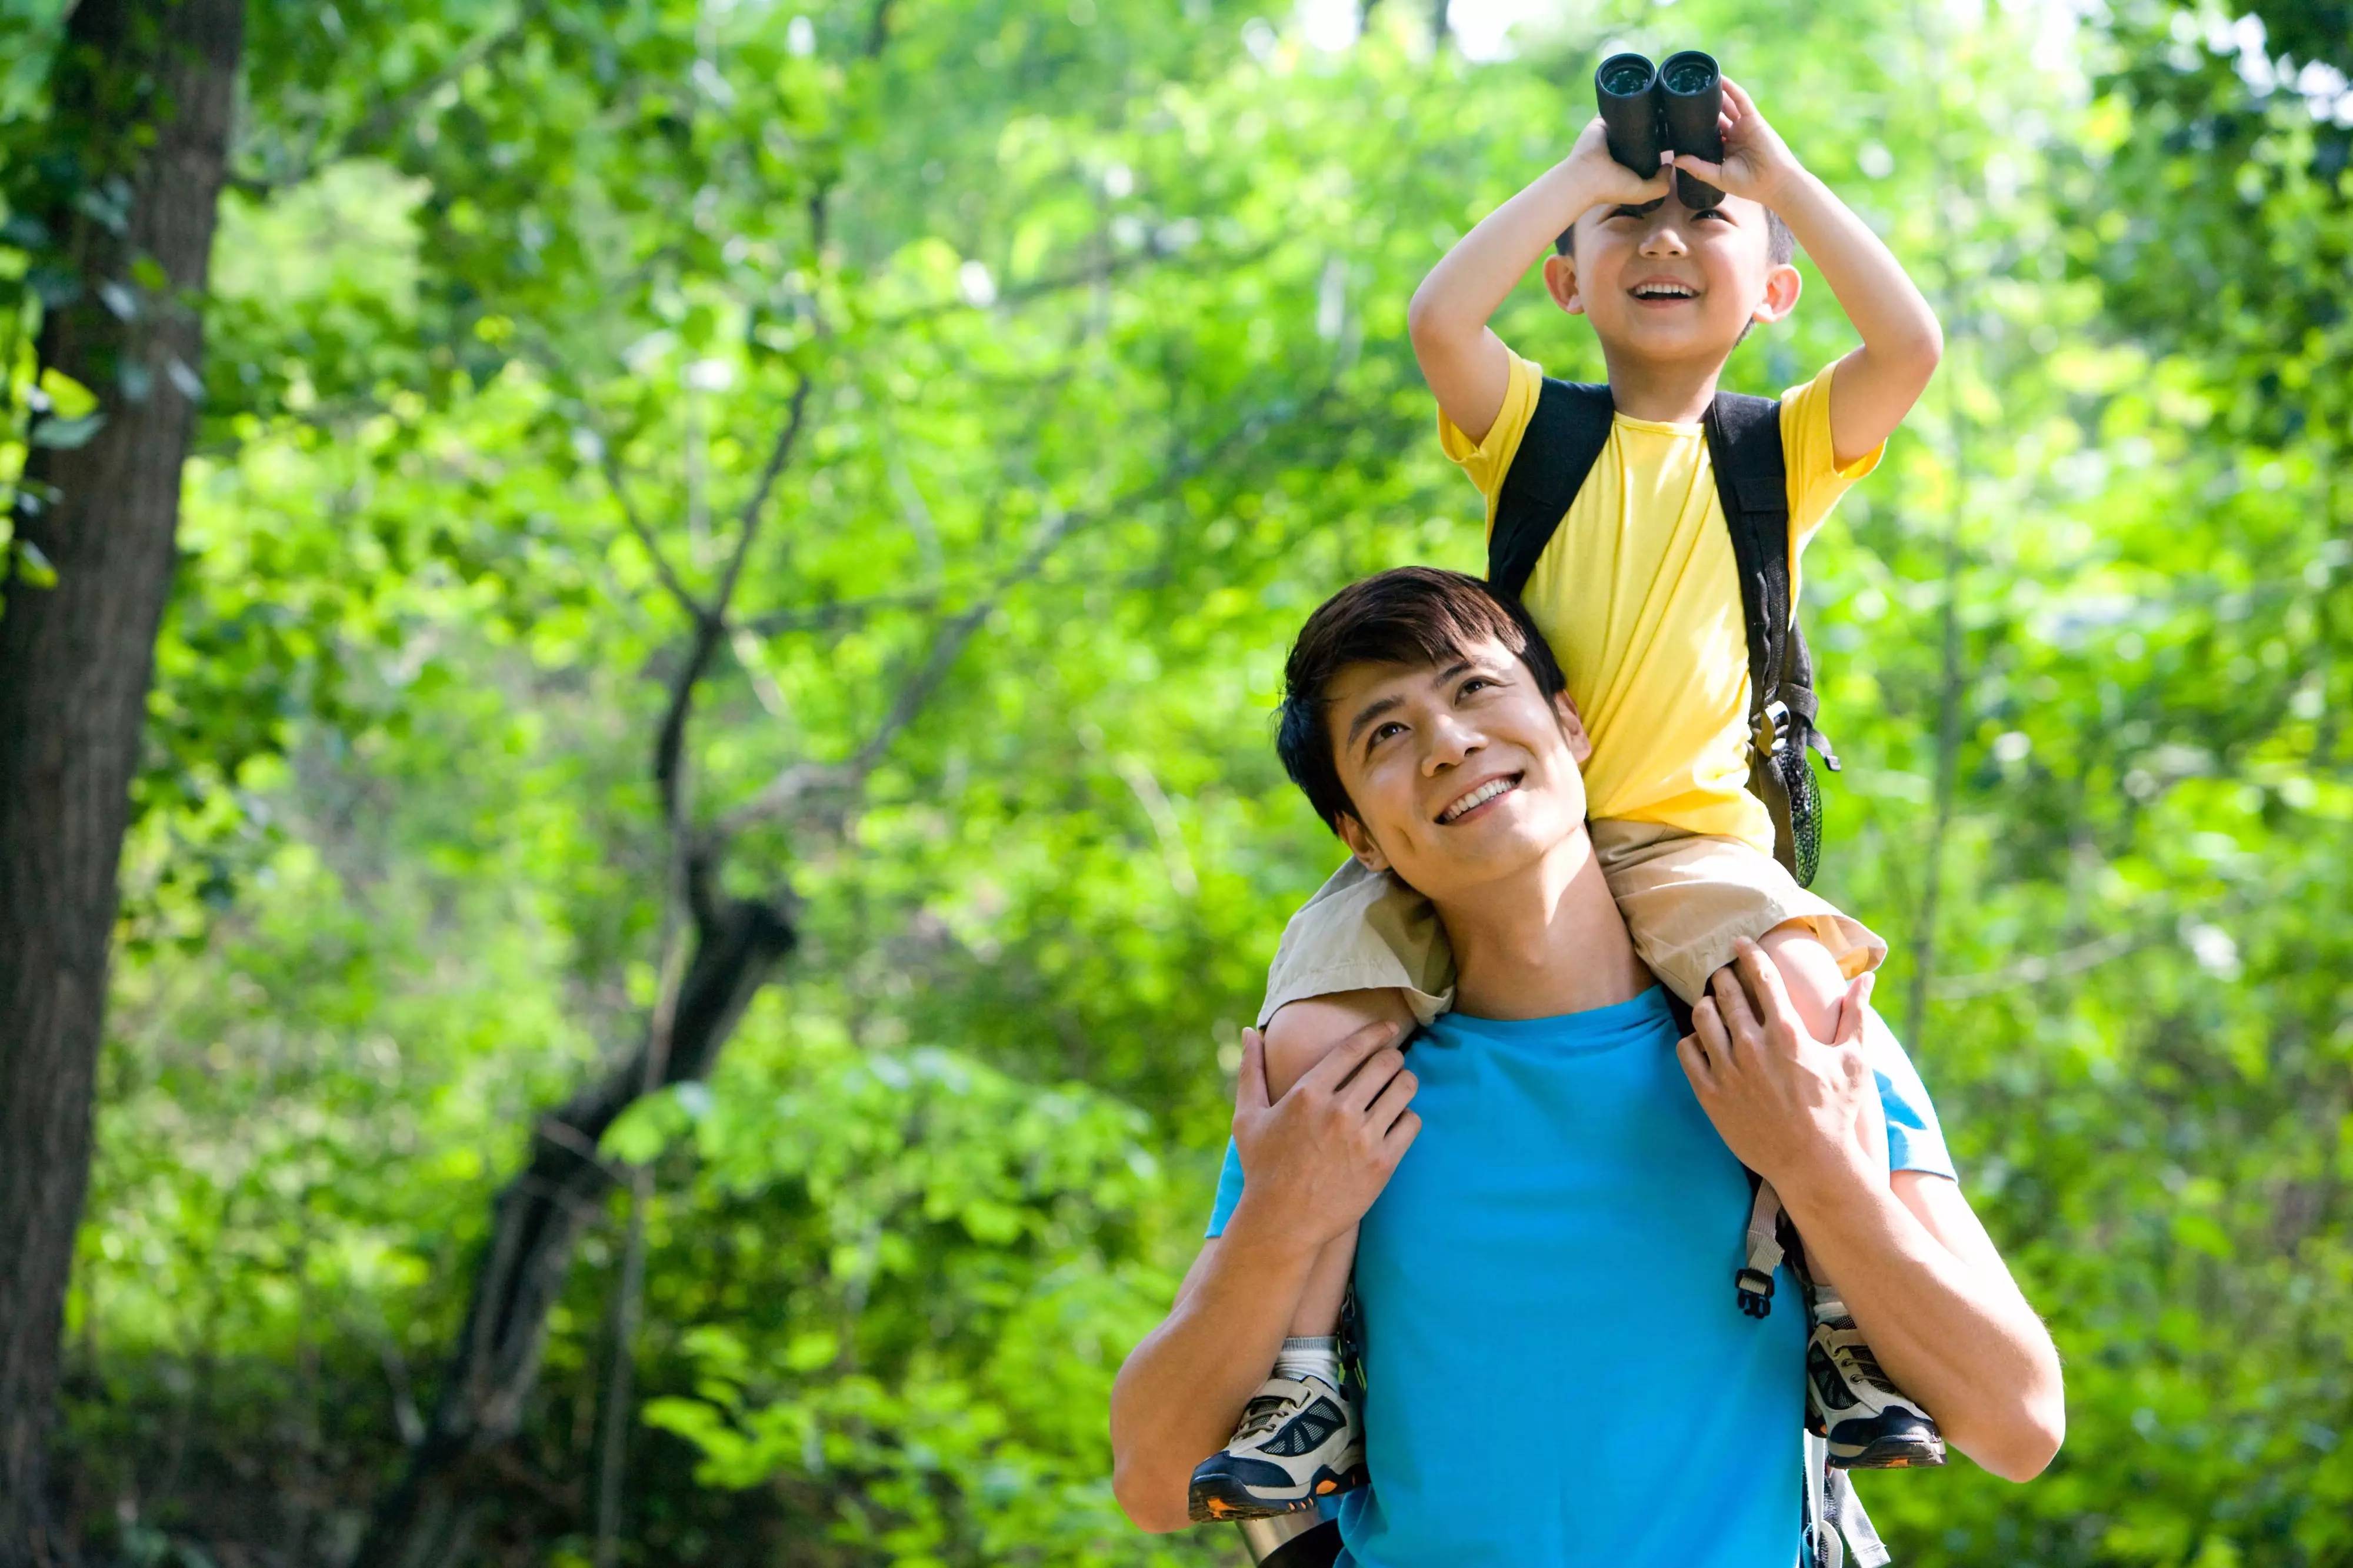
0, 0, 245, 1568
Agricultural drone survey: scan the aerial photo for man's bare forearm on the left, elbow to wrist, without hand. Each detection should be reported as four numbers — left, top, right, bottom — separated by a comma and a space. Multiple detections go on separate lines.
1111, 1189, 1318, 1530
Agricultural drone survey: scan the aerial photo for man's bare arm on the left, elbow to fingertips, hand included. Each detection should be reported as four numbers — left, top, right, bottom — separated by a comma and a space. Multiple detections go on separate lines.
1111, 1022, 1421, 1530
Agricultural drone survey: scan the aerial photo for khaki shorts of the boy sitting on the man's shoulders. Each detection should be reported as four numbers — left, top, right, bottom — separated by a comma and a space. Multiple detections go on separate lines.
1259, 819, 1887, 1029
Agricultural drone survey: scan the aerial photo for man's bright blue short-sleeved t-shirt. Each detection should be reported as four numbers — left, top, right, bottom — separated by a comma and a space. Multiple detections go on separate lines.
1209, 989, 1953, 1568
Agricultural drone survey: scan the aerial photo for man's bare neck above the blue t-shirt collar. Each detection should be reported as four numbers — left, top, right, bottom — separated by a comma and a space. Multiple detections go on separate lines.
1438, 829, 1652, 1019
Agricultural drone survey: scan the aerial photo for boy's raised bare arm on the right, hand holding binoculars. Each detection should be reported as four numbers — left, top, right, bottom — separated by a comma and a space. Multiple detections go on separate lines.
1675, 78, 1944, 466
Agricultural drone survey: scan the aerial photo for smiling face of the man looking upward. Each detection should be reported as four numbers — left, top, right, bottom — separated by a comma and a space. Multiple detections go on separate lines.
1325, 638, 1593, 904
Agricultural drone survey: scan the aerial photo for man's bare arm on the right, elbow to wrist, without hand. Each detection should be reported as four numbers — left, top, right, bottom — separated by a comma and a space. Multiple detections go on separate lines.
1781, 1172, 2066, 1481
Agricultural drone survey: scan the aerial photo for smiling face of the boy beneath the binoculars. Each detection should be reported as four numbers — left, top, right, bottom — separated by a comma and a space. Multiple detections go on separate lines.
1544, 193, 1798, 365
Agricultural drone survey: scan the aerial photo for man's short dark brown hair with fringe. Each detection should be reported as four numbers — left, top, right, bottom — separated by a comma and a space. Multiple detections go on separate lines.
1275, 568, 1569, 833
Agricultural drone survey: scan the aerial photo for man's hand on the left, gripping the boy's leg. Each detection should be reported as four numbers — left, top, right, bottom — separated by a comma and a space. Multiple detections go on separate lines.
1233, 1022, 1421, 1246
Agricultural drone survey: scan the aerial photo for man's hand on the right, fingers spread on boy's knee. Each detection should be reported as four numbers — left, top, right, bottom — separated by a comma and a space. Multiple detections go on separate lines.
1675, 942, 1887, 1194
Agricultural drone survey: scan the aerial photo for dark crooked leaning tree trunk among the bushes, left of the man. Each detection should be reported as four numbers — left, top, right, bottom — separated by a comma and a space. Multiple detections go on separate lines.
353, 866, 795, 1568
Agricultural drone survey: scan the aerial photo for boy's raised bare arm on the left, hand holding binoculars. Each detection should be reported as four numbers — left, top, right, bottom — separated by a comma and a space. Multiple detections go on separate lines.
1405, 115, 1666, 441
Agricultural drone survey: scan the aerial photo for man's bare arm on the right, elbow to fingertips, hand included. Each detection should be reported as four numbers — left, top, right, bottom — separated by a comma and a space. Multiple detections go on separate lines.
1680, 944, 2066, 1481
